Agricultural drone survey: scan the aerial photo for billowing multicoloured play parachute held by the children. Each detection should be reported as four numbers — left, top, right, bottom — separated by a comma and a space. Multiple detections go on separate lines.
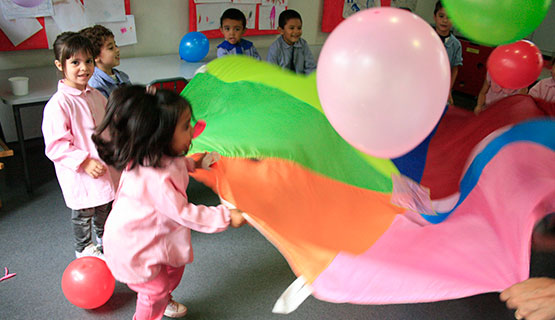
182, 56, 555, 312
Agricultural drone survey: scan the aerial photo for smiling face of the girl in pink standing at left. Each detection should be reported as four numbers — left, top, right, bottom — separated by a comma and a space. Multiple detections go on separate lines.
54, 52, 94, 90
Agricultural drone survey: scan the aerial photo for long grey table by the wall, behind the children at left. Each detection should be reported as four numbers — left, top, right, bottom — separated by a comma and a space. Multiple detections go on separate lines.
0, 54, 208, 193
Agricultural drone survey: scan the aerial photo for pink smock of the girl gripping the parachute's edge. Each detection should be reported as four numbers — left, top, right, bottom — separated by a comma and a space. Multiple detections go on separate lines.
103, 157, 231, 283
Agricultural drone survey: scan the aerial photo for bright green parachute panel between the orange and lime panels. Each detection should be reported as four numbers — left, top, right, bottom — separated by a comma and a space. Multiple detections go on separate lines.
182, 73, 398, 193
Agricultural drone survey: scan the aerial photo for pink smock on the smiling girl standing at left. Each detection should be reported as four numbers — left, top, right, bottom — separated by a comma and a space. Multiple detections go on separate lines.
42, 80, 115, 210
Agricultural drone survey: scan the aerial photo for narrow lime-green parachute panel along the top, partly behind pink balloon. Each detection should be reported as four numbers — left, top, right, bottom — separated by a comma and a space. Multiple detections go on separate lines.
206, 55, 398, 177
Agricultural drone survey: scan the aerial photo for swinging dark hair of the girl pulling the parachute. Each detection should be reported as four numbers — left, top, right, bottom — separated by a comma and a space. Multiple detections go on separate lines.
92, 85, 192, 170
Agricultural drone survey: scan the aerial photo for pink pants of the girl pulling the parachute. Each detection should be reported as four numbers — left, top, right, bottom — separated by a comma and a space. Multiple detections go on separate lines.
127, 265, 185, 320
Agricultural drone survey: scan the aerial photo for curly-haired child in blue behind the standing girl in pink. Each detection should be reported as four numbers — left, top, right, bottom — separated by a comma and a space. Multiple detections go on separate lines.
79, 24, 131, 98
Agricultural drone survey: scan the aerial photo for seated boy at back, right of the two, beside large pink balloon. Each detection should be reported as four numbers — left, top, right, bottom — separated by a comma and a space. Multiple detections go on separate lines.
266, 9, 316, 74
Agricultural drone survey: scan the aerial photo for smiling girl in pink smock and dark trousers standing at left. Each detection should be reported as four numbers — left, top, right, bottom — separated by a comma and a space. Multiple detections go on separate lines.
42, 32, 115, 258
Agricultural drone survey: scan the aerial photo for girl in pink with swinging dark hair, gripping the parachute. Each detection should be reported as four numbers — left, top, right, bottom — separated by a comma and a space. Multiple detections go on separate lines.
93, 86, 245, 320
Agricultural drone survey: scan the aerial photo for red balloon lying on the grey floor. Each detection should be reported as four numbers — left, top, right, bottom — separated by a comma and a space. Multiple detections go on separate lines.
62, 257, 116, 309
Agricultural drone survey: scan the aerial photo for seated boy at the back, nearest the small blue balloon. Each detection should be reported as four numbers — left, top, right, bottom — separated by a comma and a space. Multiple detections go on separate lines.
217, 8, 260, 60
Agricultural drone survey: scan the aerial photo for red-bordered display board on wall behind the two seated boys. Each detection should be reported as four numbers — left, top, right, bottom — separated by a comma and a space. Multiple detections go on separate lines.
189, 0, 287, 39
